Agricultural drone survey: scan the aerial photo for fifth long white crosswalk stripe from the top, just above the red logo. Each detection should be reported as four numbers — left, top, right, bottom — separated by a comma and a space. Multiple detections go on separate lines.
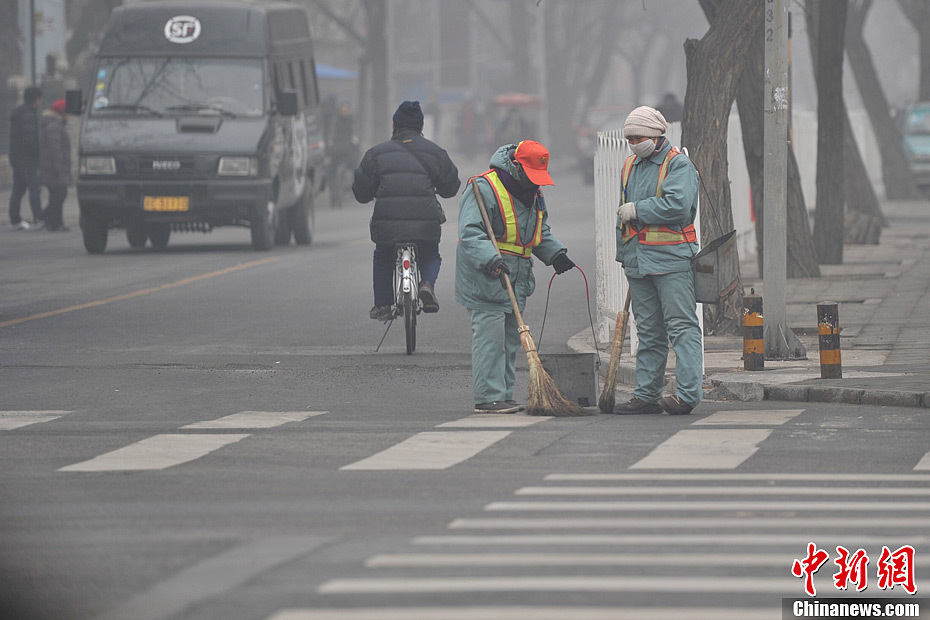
411, 532, 930, 548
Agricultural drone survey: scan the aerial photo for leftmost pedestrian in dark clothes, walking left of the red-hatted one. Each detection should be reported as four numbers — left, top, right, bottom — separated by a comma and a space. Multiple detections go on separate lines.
9, 86, 42, 230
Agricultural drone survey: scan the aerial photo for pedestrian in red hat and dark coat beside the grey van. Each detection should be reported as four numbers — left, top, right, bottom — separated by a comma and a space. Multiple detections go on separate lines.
39, 99, 71, 232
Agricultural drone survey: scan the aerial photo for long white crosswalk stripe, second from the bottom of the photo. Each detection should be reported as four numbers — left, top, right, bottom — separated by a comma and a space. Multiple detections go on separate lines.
318, 571, 798, 594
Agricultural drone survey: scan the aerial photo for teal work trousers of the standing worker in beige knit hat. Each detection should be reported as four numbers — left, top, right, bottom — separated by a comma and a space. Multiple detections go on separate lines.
628, 271, 704, 407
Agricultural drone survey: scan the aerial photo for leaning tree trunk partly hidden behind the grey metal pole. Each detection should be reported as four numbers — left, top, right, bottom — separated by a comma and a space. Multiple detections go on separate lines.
736, 23, 820, 278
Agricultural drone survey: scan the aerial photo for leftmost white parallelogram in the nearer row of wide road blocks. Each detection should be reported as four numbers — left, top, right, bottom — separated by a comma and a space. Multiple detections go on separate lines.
58, 434, 249, 472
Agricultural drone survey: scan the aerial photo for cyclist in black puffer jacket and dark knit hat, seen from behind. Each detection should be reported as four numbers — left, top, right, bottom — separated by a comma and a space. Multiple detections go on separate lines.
352, 101, 462, 321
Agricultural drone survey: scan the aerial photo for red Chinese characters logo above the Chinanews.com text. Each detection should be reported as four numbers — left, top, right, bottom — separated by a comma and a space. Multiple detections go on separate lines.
791, 543, 917, 596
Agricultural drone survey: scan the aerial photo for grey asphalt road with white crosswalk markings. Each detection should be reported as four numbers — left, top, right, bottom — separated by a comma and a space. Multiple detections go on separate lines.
0, 173, 930, 620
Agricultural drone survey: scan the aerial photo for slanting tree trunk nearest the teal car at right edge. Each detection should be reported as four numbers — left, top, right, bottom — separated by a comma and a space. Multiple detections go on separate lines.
844, 0, 921, 199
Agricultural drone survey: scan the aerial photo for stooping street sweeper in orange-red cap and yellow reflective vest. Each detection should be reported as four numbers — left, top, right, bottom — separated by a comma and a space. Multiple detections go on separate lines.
455, 140, 575, 413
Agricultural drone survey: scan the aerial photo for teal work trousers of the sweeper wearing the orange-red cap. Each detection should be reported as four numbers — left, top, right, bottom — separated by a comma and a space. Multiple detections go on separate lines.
468, 309, 522, 405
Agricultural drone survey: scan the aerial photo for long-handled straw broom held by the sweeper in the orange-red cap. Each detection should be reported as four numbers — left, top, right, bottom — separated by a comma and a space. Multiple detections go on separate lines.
471, 181, 591, 417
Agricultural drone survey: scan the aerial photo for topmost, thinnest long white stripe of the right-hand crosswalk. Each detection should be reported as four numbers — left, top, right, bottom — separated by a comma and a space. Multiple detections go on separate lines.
545, 474, 930, 483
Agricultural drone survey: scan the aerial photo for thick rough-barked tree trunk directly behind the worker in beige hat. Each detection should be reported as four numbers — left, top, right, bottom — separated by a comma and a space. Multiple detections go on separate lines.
681, 0, 763, 334
